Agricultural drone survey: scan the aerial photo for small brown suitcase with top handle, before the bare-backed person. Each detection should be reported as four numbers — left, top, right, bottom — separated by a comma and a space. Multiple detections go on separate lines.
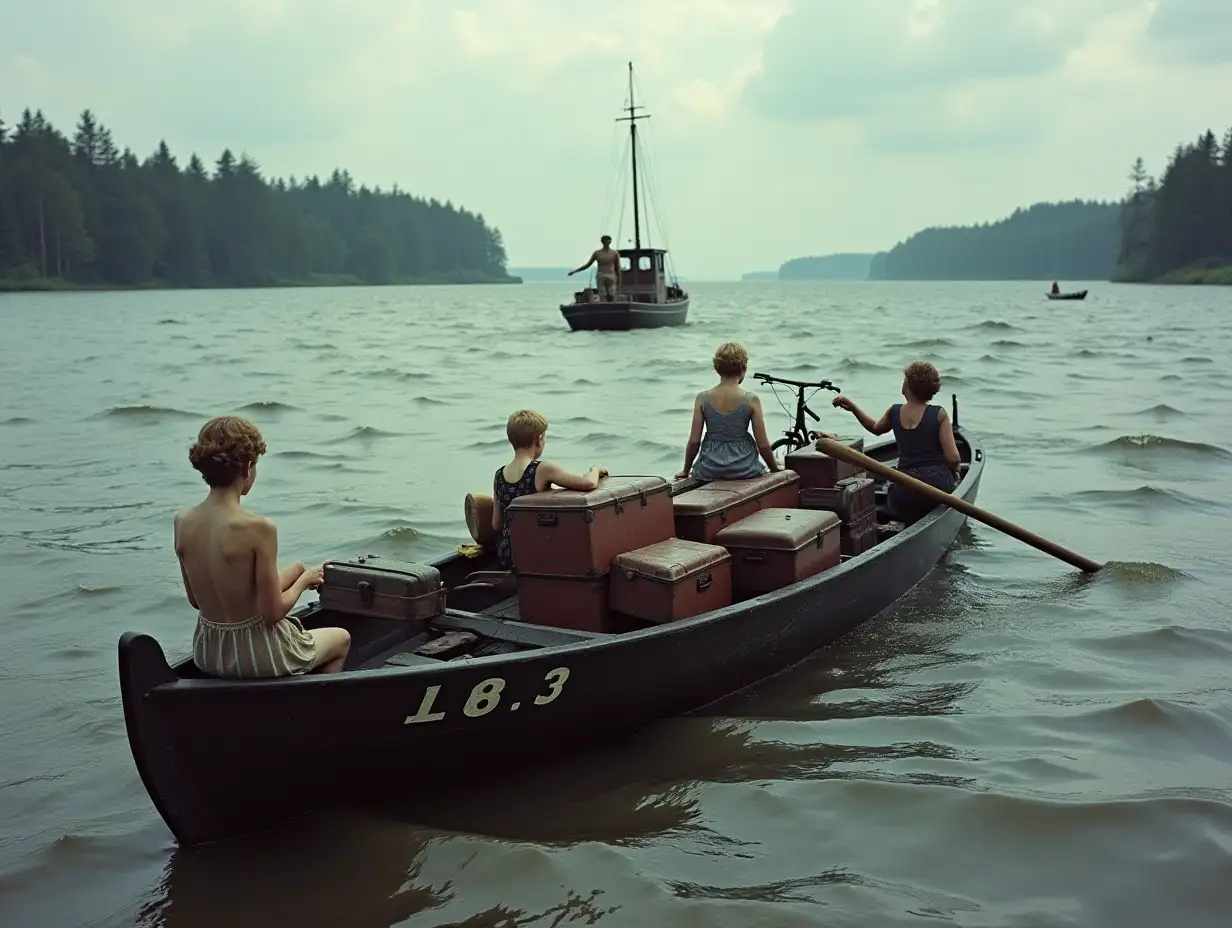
318, 560, 445, 621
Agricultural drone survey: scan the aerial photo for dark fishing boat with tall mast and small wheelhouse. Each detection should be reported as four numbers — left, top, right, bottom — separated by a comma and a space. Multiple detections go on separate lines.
561, 62, 689, 332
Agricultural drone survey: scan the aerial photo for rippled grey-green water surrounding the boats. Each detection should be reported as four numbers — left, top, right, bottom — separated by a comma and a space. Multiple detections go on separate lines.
0, 282, 1232, 928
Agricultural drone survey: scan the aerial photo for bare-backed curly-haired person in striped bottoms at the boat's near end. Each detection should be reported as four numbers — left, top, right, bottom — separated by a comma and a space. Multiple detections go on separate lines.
175, 415, 351, 679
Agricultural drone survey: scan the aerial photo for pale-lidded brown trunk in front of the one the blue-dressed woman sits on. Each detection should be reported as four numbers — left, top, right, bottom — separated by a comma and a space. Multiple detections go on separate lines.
716, 509, 841, 594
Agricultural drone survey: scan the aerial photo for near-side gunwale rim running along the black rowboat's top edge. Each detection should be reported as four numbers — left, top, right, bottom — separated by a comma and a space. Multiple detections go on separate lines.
129, 426, 987, 693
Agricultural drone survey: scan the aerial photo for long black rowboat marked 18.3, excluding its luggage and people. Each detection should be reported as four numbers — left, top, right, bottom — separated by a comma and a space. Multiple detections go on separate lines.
118, 428, 986, 845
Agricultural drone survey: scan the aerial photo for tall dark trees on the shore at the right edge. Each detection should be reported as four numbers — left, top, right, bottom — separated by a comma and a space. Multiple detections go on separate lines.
1116, 128, 1232, 283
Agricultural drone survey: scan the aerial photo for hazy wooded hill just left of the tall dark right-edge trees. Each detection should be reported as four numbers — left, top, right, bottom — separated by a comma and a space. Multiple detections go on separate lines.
869, 200, 1121, 281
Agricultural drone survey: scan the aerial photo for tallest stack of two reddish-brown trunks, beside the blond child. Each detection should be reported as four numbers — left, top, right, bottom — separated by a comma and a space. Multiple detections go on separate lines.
504, 477, 675, 632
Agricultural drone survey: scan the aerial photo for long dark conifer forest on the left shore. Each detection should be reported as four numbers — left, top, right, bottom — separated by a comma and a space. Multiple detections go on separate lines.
0, 110, 516, 288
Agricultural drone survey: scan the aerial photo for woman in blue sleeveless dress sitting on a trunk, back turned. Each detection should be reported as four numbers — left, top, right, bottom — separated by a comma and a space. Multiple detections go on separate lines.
676, 341, 780, 481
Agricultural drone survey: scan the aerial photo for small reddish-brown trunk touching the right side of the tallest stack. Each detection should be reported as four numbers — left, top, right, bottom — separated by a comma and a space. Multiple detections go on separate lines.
609, 539, 732, 622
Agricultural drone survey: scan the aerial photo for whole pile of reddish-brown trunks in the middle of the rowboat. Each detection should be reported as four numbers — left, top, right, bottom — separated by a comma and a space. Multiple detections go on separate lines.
505, 463, 871, 632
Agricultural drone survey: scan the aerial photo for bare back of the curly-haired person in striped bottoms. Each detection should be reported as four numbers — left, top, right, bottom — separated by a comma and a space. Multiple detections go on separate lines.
175, 500, 265, 622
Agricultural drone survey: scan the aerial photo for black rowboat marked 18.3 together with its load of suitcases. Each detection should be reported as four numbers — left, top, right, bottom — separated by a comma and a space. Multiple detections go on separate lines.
118, 394, 984, 845
